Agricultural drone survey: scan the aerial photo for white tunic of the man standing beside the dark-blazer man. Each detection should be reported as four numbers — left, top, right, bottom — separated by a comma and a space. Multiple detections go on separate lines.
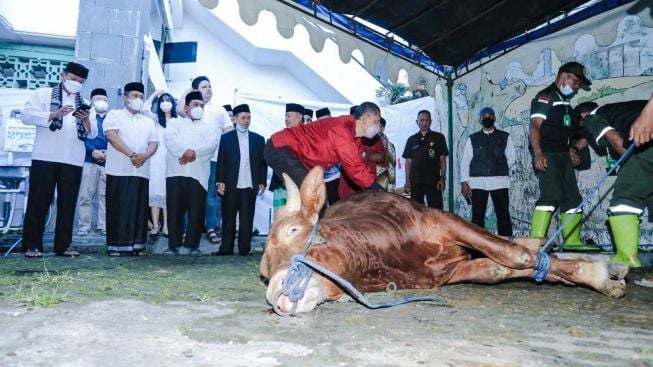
164, 117, 220, 190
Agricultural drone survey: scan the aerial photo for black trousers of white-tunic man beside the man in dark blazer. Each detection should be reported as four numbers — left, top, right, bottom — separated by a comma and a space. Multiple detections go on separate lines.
166, 176, 206, 249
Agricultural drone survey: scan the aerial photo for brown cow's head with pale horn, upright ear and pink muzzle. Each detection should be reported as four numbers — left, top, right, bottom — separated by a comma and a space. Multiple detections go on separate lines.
260, 167, 326, 312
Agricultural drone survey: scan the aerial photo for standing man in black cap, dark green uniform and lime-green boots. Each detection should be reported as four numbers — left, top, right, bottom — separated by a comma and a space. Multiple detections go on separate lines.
529, 62, 599, 251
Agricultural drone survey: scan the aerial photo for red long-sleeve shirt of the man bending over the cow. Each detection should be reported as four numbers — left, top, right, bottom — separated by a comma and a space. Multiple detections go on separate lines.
270, 115, 376, 188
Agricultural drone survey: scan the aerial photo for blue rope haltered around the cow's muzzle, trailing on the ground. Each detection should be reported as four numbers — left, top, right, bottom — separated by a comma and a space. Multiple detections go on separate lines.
272, 223, 447, 316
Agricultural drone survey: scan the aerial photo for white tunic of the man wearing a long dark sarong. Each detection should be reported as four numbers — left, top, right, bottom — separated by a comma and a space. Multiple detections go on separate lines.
102, 108, 159, 179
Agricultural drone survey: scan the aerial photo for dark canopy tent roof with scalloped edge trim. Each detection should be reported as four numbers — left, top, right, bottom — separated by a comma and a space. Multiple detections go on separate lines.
199, 0, 651, 84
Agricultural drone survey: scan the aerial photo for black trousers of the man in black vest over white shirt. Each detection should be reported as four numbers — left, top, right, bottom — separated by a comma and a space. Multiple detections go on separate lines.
472, 189, 512, 237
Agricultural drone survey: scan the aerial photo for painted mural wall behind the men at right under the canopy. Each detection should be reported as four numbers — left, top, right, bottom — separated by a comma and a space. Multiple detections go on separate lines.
446, 6, 653, 244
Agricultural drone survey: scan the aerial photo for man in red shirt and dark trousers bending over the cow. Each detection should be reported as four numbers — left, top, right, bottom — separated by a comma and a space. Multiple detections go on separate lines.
264, 102, 381, 190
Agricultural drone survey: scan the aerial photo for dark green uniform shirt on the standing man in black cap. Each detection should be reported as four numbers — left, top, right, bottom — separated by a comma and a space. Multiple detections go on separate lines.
531, 84, 572, 152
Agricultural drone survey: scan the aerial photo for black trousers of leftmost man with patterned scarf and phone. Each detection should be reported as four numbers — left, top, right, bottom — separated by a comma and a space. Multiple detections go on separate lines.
23, 160, 82, 253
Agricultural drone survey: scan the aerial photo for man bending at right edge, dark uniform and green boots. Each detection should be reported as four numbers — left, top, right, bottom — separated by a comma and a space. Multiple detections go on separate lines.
574, 100, 653, 270
